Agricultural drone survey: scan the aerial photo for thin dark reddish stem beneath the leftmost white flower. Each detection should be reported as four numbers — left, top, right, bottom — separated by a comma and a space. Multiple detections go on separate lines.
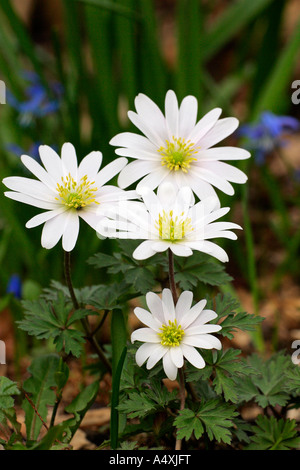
64, 251, 112, 373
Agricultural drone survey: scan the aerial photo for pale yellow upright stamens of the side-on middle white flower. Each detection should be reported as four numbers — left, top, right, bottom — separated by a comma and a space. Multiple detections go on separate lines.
155, 211, 194, 242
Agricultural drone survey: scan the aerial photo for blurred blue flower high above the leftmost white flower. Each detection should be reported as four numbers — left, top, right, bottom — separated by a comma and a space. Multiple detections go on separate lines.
7, 72, 63, 127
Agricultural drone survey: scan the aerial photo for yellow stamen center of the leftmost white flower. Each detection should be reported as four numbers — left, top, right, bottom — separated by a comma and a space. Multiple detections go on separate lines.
55, 173, 99, 210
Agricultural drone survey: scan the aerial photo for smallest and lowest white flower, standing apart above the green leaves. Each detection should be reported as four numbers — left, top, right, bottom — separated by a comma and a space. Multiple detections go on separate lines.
131, 289, 222, 380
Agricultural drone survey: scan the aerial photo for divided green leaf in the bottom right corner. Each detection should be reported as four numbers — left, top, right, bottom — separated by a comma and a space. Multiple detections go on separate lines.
246, 415, 300, 450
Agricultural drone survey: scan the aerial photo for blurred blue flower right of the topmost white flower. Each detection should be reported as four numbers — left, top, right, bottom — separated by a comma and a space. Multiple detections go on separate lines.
238, 111, 300, 165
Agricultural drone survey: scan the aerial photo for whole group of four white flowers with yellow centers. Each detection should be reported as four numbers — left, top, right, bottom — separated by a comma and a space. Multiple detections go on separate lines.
3, 90, 250, 380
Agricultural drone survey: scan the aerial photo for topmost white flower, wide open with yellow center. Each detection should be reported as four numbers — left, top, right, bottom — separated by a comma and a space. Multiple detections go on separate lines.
110, 90, 250, 199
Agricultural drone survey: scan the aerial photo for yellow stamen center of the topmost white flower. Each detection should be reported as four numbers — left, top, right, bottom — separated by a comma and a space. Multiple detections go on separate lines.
158, 136, 199, 173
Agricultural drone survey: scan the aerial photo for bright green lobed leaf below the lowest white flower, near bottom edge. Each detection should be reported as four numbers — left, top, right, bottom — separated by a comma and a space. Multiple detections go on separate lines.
174, 399, 238, 444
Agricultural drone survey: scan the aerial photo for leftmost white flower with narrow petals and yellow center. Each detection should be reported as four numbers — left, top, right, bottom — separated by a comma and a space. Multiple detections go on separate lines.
3, 143, 136, 251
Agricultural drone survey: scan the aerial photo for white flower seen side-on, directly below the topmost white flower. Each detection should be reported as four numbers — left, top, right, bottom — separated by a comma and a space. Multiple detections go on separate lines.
97, 183, 241, 262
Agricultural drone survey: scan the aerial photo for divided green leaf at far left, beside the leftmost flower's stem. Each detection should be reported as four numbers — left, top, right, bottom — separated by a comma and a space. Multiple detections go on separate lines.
17, 292, 93, 357
